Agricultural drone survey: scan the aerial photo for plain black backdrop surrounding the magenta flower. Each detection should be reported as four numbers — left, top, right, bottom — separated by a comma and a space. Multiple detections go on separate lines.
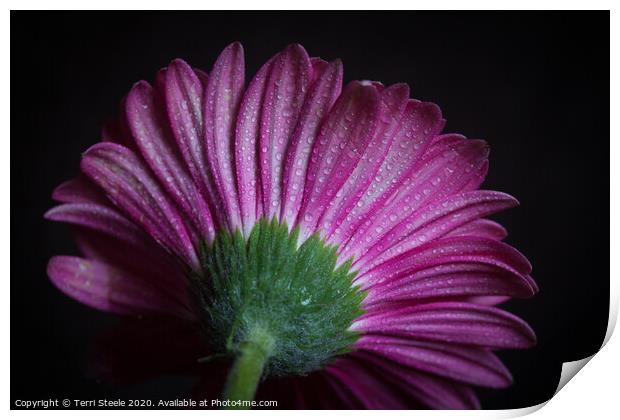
11, 12, 609, 408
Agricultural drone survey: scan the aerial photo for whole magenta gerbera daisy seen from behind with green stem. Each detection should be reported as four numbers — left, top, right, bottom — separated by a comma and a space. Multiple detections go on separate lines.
46, 43, 537, 408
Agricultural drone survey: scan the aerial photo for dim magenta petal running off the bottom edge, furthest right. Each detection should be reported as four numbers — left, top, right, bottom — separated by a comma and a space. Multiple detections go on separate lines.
352, 351, 480, 410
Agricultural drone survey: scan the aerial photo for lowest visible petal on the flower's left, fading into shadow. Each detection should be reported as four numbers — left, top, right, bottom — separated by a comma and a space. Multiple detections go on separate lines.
47, 256, 187, 317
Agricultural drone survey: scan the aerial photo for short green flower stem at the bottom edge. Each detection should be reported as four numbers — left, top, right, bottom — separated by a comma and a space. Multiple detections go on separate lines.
224, 330, 273, 408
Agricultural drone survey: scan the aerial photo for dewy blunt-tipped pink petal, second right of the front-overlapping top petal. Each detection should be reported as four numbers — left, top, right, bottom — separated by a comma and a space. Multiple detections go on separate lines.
331, 100, 441, 243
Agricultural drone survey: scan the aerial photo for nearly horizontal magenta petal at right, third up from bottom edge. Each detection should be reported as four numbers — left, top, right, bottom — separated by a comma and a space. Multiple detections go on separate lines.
351, 302, 536, 348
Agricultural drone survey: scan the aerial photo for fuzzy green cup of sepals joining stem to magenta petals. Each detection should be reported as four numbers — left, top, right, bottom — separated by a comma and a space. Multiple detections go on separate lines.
190, 219, 364, 379
